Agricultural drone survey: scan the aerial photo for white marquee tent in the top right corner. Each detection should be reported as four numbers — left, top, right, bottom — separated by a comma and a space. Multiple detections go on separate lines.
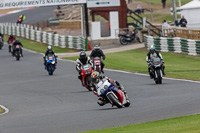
180, 0, 200, 28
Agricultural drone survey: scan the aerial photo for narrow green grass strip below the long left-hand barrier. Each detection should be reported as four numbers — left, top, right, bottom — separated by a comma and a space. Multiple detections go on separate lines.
4, 35, 76, 53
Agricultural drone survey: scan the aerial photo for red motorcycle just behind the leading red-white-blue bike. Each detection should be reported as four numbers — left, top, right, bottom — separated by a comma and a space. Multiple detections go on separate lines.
81, 64, 93, 91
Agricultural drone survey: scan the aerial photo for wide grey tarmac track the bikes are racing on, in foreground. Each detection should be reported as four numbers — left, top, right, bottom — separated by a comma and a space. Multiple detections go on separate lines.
0, 45, 200, 133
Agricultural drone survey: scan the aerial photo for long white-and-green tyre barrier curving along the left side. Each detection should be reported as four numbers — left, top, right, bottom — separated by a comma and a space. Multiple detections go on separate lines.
0, 23, 87, 50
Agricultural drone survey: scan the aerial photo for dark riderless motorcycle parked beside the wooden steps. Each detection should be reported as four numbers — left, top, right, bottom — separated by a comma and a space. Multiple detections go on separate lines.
119, 29, 141, 45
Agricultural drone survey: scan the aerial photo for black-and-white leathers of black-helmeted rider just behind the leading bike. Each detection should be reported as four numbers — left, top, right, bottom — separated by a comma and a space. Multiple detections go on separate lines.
76, 57, 93, 81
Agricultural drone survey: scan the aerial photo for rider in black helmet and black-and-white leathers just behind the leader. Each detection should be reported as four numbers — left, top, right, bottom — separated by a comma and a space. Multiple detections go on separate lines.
76, 51, 93, 82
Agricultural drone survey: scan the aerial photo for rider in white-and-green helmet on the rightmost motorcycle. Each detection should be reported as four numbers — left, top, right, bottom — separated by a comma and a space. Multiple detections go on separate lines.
146, 45, 165, 78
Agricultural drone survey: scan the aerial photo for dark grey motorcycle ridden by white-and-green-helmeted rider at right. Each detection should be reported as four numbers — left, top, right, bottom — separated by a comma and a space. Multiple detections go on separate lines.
149, 58, 163, 84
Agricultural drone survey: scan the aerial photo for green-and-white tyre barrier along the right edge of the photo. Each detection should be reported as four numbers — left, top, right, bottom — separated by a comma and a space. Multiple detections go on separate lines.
144, 35, 200, 55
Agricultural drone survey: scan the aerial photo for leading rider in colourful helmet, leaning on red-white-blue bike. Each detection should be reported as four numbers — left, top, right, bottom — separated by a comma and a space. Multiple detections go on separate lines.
91, 71, 129, 106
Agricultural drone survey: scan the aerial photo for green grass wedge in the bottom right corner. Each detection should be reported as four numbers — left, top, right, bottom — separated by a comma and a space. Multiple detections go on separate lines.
84, 114, 200, 133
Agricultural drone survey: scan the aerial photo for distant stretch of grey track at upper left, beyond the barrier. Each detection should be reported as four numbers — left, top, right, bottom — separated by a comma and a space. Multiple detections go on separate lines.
0, 6, 56, 24
